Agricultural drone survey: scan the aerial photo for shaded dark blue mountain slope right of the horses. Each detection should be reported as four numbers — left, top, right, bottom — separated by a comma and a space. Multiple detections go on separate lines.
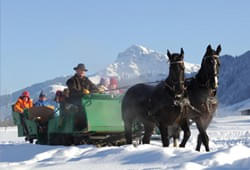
218, 51, 250, 105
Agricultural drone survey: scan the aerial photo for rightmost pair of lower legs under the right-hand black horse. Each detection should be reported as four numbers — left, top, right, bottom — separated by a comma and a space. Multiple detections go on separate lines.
196, 121, 209, 152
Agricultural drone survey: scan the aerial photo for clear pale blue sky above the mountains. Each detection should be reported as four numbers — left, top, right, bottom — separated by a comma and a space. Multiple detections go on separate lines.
0, 0, 250, 94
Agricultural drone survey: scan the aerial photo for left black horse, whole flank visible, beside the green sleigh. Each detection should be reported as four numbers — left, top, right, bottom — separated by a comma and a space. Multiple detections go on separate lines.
122, 49, 184, 146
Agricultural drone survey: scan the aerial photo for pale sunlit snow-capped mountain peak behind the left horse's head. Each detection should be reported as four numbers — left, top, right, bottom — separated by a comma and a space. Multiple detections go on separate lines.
97, 45, 200, 85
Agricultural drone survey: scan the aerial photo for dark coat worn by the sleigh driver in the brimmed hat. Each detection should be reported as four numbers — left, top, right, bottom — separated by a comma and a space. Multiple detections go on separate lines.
66, 74, 98, 97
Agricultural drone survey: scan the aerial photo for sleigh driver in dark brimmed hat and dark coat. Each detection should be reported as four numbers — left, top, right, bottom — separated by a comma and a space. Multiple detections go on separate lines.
66, 64, 98, 99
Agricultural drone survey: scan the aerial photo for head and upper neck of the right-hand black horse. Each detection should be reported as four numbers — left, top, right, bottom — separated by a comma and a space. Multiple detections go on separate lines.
197, 45, 221, 89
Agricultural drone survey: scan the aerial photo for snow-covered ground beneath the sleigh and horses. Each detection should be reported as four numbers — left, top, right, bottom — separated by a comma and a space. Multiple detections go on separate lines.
0, 116, 250, 170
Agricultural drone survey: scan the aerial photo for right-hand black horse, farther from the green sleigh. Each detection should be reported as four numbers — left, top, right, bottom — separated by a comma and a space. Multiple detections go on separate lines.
180, 45, 221, 151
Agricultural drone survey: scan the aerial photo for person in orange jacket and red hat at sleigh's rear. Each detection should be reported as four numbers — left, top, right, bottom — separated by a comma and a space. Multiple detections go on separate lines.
14, 91, 33, 114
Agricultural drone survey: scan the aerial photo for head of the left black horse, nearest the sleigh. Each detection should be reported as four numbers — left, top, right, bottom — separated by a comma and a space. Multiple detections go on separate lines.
165, 48, 185, 95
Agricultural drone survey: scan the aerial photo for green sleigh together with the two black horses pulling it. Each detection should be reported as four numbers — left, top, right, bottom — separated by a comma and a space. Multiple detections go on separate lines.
13, 45, 221, 151
